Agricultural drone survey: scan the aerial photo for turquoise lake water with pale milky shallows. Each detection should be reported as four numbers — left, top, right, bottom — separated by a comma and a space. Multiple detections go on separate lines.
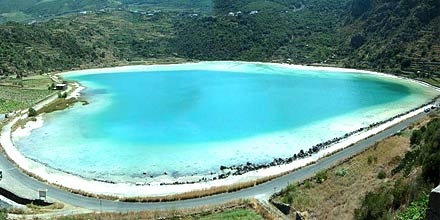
15, 63, 434, 181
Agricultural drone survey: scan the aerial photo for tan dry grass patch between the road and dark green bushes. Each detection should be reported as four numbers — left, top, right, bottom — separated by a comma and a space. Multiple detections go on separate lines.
275, 116, 436, 219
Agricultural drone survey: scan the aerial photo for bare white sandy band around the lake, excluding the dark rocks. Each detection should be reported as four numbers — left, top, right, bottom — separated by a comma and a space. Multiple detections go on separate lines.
0, 62, 438, 197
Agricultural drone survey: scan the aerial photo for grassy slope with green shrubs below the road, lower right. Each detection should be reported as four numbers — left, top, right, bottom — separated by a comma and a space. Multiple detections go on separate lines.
274, 111, 440, 219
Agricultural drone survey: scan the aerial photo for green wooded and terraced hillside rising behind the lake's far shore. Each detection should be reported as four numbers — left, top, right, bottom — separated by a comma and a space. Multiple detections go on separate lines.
0, 0, 440, 80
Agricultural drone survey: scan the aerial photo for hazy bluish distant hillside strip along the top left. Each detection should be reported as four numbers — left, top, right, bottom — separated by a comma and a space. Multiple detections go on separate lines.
0, 0, 212, 23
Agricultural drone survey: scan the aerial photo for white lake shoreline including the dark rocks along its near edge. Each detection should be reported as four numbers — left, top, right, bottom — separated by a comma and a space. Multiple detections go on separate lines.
0, 62, 438, 197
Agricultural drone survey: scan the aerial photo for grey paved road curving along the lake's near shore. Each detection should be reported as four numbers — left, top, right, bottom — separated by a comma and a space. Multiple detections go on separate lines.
0, 113, 434, 212
